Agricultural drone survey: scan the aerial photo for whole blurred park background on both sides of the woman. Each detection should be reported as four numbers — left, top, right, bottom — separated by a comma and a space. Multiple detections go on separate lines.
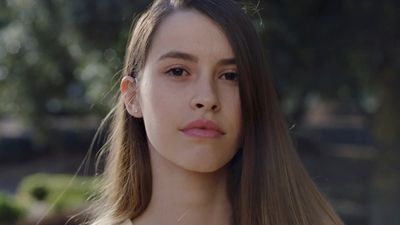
0, 0, 400, 225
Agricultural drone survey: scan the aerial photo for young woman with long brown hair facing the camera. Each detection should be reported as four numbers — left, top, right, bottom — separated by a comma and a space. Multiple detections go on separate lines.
92, 0, 342, 225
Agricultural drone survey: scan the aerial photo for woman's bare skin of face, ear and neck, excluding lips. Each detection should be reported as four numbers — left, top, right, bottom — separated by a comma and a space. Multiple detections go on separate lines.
121, 10, 241, 225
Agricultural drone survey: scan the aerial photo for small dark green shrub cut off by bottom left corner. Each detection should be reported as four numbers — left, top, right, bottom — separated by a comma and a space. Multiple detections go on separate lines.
0, 193, 24, 224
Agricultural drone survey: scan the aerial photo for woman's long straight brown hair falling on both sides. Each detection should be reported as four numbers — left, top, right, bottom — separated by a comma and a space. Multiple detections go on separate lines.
92, 0, 342, 225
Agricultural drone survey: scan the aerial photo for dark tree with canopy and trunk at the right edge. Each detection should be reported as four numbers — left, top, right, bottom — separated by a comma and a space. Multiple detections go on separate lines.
263, 0, 400, 224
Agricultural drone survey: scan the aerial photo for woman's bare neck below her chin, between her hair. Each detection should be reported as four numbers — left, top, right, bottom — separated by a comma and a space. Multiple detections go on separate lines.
134, 146, 231, 225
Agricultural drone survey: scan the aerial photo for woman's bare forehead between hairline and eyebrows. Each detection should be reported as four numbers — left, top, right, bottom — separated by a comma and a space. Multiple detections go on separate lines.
148, 10, 234, 61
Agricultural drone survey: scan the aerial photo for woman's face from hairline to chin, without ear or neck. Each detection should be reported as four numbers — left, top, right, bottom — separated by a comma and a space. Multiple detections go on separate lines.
137, 10, 241, 172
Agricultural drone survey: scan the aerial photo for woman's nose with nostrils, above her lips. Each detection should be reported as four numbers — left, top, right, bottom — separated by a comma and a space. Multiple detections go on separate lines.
190, 78, 221, 112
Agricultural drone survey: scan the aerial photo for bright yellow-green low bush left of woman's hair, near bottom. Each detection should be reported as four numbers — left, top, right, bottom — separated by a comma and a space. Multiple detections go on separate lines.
16, 174, 95, 212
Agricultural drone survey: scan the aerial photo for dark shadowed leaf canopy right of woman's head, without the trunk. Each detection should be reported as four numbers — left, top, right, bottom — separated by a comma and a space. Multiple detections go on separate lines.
261, 0, 400, 114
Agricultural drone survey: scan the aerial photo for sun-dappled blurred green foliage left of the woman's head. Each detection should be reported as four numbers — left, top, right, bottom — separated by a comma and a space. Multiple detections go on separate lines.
0, 0, 149, 121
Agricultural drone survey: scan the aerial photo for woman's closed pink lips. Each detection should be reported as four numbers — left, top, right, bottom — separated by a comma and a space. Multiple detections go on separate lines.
181, 119, 225, 138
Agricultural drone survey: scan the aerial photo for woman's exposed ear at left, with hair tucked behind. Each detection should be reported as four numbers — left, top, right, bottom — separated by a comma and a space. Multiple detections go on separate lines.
120, 76, 143, 118
